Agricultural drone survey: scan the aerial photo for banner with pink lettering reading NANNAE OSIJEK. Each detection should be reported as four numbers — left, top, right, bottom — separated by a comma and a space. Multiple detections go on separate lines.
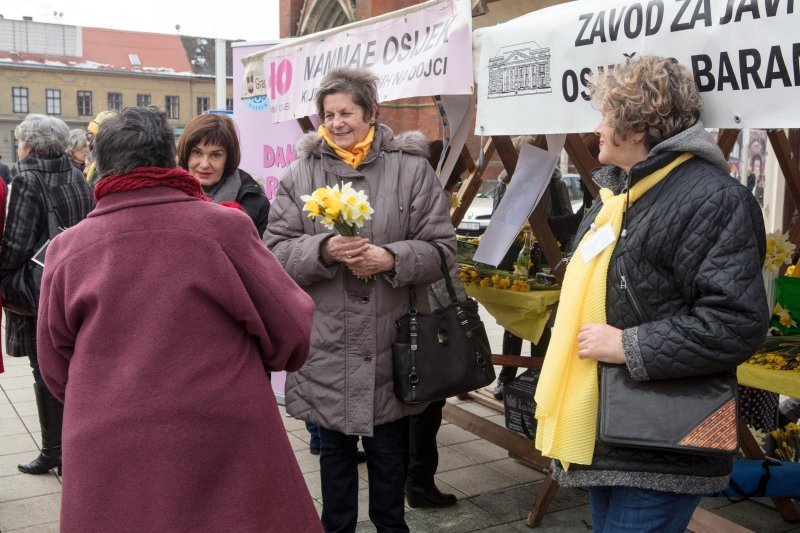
242, 0, 473, 122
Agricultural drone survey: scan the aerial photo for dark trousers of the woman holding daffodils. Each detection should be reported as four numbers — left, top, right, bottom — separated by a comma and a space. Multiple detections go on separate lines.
319, 418, 408, 533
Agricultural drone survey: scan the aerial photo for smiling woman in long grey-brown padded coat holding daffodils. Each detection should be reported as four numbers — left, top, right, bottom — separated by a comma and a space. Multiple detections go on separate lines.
264, 68, 456, 532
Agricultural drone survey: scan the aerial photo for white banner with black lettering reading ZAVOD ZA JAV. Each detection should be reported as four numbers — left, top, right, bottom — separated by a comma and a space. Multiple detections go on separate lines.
475, 0, 800, 135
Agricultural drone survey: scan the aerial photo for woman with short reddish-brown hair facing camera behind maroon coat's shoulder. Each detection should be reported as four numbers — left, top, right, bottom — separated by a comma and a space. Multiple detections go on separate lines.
178, 113, 269, 235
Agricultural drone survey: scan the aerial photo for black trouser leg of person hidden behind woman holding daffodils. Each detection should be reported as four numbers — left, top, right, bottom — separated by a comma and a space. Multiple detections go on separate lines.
406, 400, 445, 489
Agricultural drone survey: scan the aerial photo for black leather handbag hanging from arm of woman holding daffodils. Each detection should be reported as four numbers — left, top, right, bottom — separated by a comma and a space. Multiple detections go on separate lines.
392, 243, 495, 404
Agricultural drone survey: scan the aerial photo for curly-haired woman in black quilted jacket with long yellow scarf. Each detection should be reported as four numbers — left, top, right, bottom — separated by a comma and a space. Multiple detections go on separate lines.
536, 56, 768, 532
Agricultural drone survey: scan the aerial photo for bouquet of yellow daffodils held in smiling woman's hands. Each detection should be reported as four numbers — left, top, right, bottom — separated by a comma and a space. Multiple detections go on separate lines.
300, 182, 375, 237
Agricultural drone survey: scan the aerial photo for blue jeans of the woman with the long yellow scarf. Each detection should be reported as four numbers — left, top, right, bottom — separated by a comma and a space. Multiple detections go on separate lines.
589, 487, 702, 533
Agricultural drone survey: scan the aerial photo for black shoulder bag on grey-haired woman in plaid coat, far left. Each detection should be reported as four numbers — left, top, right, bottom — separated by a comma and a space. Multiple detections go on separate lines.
1, 175, 64, 317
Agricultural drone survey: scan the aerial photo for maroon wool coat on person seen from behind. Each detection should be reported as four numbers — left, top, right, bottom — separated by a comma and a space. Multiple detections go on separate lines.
38, 187, 322, 532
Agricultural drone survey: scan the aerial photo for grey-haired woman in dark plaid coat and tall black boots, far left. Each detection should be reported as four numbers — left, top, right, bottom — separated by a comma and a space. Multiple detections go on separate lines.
0, 115, 92, 474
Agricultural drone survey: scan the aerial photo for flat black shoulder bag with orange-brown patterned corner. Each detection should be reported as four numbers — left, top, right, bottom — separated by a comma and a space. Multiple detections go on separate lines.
597, 363, 739, 456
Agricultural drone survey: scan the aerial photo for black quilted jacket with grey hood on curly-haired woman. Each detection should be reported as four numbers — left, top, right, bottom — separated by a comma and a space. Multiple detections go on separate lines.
557, 123, 768, 494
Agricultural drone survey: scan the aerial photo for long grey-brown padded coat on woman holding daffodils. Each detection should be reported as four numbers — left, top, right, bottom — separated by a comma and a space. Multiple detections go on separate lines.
264, 125, 456, 436
